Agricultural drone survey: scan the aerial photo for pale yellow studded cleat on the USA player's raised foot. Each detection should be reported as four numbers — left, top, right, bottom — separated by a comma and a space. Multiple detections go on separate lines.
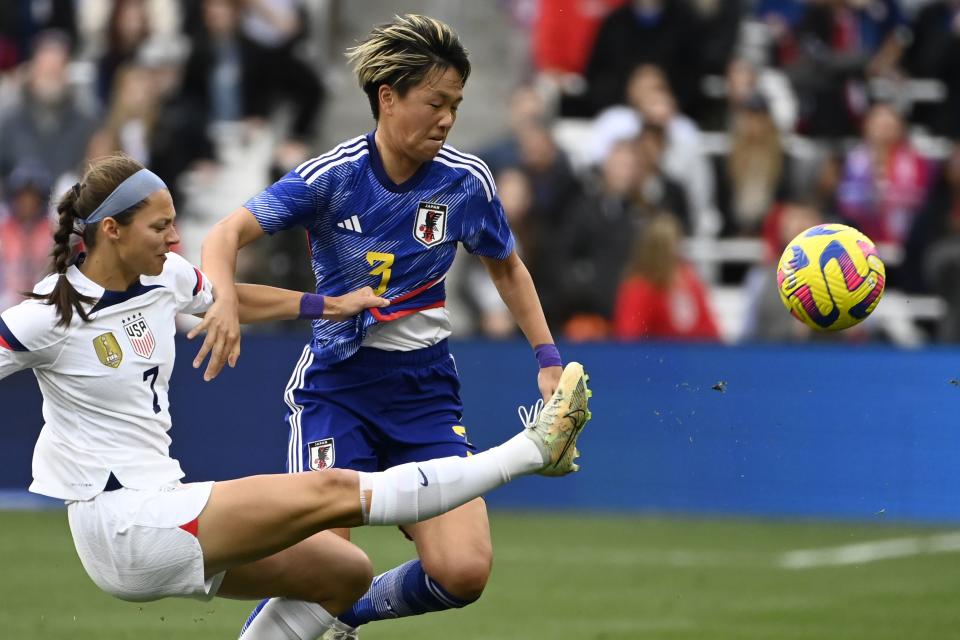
520, 362, 593, 476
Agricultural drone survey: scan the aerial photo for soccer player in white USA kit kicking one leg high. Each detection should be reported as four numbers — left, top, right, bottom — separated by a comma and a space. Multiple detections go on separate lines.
0, 156, 589, 640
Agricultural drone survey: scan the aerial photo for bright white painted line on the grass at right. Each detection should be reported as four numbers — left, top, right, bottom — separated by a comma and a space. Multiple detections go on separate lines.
779, 532, 960, 569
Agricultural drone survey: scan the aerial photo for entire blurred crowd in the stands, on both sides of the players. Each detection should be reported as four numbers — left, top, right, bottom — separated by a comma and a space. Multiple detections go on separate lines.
0, 0, 960, 342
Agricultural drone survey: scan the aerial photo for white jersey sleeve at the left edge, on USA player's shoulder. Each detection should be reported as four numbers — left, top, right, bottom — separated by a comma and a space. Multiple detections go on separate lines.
0, 300, 67, 379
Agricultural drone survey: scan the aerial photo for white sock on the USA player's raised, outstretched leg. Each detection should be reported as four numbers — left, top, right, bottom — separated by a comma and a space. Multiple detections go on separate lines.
360, 433, 544, 525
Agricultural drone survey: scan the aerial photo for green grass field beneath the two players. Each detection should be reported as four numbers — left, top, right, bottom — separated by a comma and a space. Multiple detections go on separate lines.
0, 511, 960, 640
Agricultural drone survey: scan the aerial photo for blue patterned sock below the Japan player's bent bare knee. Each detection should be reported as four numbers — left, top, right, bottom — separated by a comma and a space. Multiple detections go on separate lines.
337, 560, 473, 627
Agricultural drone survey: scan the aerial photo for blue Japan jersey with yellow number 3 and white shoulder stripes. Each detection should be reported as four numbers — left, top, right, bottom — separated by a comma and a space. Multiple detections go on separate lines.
245, 132, 514, 363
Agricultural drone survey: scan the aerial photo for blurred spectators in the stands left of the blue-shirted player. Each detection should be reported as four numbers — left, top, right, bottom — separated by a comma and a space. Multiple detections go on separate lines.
0, 0, 325, 308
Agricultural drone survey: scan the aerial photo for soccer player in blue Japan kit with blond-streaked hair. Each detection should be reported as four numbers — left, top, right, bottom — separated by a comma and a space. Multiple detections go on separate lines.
195, 15, 575, 627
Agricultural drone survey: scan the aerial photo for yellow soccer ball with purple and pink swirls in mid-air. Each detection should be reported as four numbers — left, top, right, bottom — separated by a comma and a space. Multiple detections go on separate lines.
777, 224, 886, 331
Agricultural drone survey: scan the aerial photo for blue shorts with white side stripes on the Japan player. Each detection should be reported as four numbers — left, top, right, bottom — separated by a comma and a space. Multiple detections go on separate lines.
284, 340, 476, 472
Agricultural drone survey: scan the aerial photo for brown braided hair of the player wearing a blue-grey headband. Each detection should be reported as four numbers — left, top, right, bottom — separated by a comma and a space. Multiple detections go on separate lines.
26, 154, 146, 326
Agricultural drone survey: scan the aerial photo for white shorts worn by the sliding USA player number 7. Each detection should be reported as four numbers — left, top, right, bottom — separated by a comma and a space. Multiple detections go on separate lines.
67, 482, 224, 602
